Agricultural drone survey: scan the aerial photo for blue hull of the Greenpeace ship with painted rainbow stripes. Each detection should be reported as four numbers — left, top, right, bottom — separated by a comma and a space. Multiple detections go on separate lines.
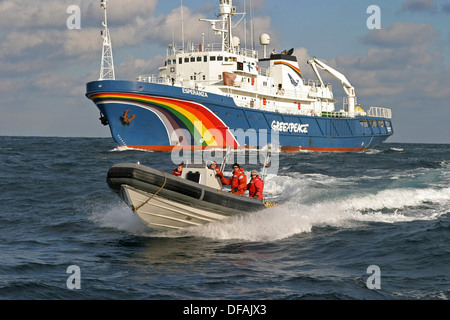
86, 80, 394, 152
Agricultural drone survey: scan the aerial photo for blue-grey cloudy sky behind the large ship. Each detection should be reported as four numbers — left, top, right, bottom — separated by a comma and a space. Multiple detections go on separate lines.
0, 0, 450, 143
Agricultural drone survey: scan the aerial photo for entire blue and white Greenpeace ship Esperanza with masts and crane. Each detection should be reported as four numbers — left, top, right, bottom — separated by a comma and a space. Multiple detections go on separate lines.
86, 0, 394, 152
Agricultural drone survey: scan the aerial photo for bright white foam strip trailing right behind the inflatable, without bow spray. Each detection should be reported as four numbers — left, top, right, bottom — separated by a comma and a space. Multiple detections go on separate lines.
178, 188, 450, 241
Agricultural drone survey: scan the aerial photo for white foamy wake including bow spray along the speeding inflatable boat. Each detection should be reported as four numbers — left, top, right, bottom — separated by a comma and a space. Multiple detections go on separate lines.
96, 188, 450, 242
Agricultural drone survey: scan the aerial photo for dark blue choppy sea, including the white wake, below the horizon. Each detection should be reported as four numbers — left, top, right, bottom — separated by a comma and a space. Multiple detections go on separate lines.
0, 137, 450, 300
